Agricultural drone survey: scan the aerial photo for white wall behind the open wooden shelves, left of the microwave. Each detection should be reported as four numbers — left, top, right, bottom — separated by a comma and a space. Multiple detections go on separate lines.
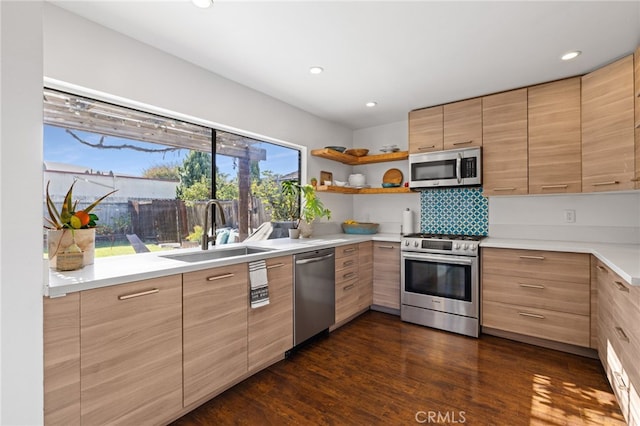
350, 121, 420, 233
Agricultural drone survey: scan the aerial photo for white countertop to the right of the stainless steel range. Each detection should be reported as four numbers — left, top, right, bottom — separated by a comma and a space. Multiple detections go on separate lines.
480, 237, 640, 286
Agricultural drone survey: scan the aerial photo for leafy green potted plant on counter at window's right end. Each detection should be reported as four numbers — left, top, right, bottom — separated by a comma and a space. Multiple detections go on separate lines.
282, 181, 331, 238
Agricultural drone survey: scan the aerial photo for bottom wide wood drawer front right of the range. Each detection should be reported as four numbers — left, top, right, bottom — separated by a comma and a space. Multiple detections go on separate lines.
482, 301, 590, 347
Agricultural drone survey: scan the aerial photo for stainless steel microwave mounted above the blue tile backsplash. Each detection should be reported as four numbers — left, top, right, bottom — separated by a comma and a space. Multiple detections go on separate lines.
409, 147, 482, 188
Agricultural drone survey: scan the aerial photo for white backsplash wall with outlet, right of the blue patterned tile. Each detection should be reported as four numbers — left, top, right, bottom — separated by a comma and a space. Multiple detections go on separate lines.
489, 191, 640, 244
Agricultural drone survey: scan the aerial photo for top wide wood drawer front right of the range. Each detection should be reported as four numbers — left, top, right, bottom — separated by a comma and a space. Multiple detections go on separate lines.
482, 248, 590, 284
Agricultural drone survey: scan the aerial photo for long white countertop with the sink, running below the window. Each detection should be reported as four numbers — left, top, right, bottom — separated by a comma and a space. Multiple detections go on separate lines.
43, 234, 400, 297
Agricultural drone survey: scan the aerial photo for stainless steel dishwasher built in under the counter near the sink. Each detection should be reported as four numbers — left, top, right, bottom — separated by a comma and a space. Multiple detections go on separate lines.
293, 248, 336, 345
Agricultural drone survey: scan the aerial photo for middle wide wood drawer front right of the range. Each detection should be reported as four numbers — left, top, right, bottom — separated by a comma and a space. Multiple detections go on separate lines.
482, 274, 590, 315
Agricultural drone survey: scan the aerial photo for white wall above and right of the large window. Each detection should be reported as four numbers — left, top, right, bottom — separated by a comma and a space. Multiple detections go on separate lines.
44, 4, 352, 223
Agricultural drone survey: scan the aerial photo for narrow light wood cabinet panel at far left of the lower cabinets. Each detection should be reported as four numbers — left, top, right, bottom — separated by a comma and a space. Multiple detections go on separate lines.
43, 293, 80, 426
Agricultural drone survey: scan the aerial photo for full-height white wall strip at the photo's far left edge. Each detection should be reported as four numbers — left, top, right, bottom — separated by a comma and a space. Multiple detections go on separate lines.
0, 1, 43, 425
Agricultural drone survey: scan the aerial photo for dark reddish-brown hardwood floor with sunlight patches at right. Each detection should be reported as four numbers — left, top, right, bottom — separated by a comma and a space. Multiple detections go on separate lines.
174, 311, 624, 426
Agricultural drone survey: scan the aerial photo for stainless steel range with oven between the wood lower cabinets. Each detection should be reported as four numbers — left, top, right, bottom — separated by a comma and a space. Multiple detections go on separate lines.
400, 234, 483, 337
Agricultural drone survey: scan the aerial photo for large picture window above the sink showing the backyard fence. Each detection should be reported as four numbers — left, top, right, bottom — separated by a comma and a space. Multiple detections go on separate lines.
43, 89, 300, 257
